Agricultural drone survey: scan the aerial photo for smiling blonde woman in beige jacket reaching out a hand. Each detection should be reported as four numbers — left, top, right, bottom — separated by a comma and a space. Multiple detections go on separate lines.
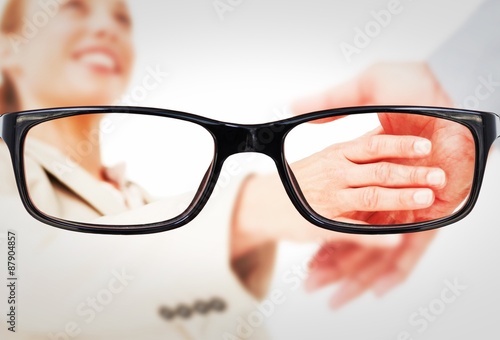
0, 0, 472, 339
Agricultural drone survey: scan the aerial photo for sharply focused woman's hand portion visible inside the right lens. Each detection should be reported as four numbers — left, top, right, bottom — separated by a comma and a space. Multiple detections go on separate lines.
291, 129, 446, 224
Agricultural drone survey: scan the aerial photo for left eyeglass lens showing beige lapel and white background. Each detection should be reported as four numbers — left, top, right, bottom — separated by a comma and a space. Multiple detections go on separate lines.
24, 113, 214, 225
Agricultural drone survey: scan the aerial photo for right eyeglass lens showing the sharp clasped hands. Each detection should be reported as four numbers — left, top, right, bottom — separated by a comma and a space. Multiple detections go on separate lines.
285, 113, 475, 226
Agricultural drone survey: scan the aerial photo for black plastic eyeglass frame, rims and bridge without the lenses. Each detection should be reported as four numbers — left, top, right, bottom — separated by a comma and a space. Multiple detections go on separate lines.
0, 106, 500, 235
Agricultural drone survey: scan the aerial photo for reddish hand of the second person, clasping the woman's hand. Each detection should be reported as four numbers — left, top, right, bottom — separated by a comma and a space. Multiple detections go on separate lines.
293, 63, 474, 308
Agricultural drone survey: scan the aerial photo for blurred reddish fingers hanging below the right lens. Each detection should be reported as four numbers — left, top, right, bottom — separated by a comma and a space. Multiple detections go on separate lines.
305, 230, 437, 309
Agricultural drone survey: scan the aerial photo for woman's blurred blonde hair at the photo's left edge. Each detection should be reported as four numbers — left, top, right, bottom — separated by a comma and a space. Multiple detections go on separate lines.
0, 0, 25, 114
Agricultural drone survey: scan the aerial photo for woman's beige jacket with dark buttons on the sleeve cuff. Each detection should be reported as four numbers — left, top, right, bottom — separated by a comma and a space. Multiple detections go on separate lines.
0, 141, 275, 340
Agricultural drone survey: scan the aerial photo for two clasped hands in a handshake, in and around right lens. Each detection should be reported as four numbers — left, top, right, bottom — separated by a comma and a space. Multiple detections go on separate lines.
286, 63, 475, 308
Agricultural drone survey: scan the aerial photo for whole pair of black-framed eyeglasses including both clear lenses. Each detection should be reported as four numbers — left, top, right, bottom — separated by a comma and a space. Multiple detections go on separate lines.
0, 106, 500, 234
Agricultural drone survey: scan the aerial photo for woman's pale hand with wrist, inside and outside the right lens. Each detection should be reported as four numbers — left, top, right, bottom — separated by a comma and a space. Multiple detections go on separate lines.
232, 129, 446, 256
